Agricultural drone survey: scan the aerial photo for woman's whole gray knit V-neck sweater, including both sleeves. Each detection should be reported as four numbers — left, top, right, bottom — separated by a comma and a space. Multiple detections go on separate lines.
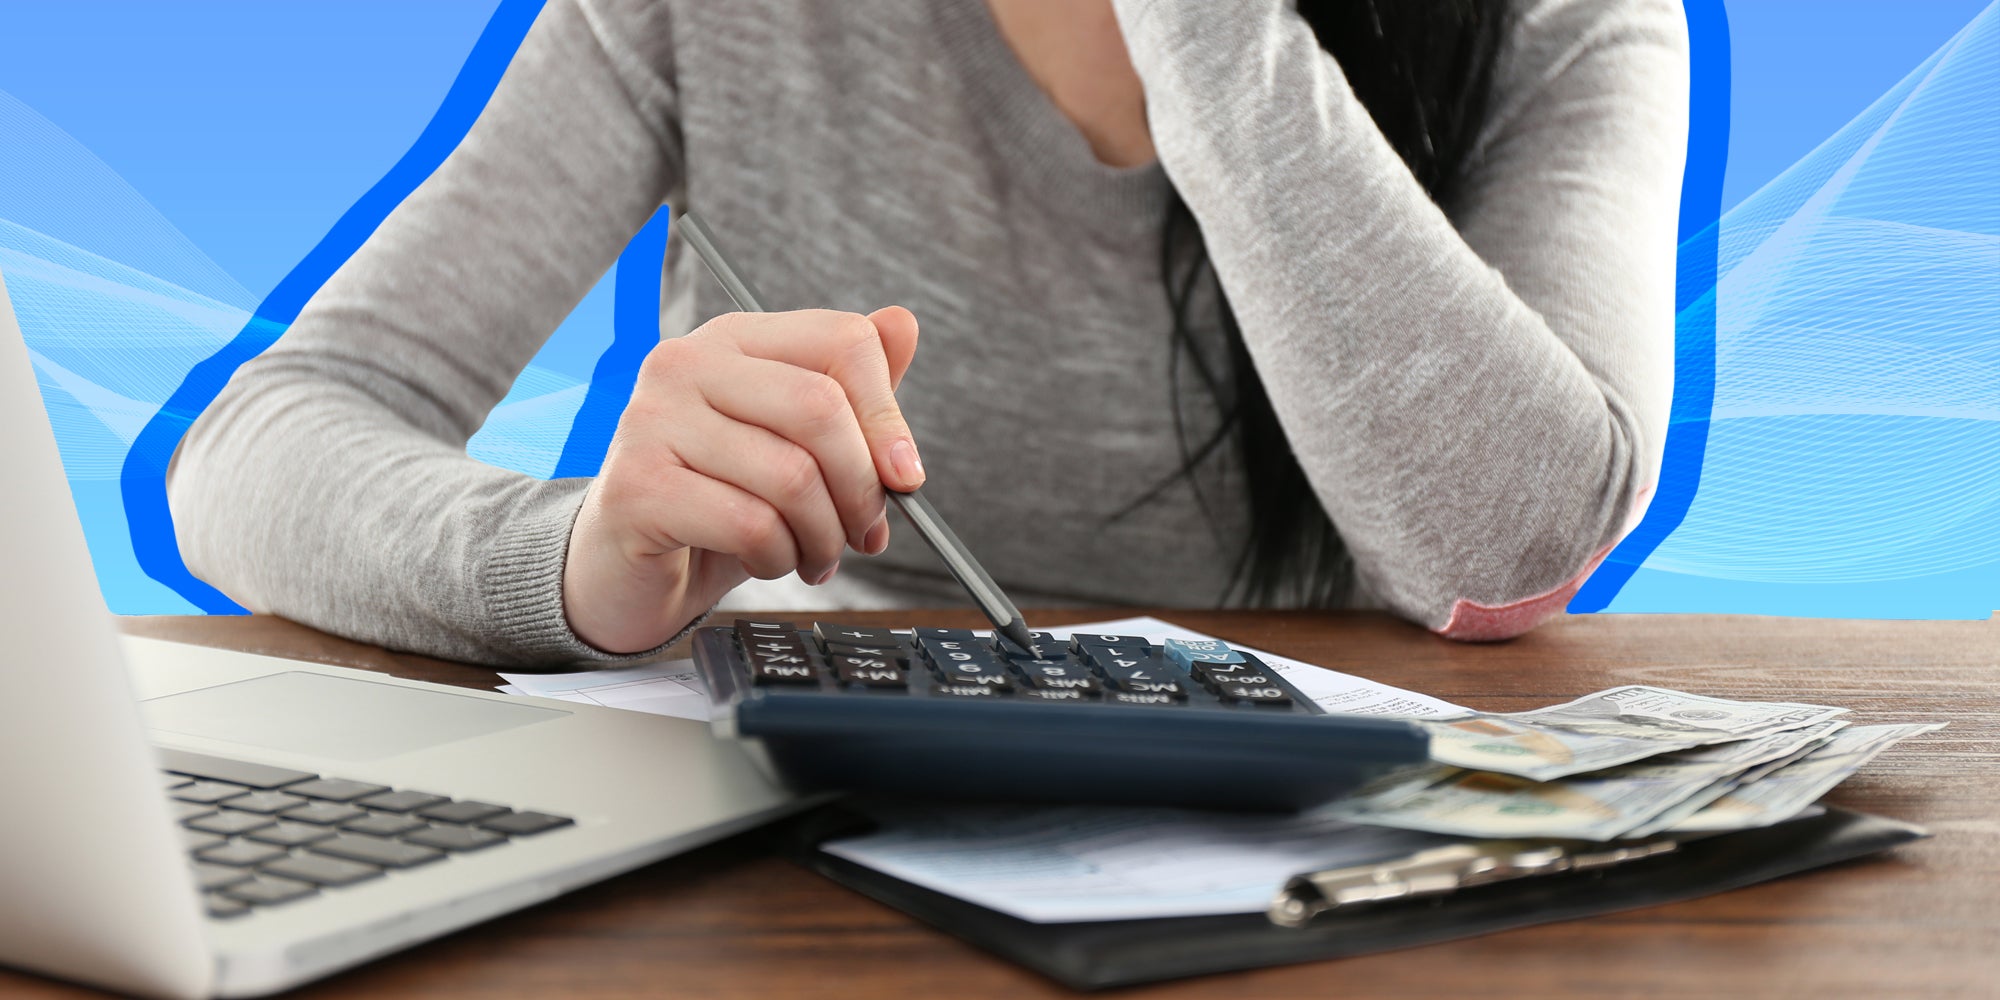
170, 0, 1688, 662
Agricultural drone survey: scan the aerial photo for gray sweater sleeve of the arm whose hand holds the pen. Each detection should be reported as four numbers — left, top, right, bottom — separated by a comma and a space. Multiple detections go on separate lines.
168, 0, 680, 662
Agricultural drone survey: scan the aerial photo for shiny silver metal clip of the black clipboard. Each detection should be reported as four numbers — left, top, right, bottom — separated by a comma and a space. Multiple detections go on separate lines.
1266, 840, 1680, 928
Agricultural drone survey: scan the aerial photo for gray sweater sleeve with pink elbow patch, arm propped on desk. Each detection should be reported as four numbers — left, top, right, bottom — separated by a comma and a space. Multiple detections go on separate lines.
1116, 0, 1688, 638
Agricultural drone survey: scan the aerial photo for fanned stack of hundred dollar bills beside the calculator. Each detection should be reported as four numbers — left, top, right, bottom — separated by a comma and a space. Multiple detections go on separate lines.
1328, 684, 1944, 840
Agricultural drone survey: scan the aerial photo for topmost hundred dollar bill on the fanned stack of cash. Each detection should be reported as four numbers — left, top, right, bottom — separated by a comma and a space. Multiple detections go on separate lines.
1424, 684, 1846, 782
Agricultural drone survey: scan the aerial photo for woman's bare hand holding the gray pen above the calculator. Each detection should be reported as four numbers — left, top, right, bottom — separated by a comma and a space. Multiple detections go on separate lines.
562, 306, 924, 652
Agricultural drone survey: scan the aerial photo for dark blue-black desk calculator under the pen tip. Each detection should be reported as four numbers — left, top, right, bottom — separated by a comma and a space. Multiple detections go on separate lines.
694, 620, 1430, 810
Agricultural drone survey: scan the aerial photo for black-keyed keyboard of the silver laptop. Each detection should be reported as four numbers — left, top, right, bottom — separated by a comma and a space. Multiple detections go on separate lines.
156, 748, 574, 918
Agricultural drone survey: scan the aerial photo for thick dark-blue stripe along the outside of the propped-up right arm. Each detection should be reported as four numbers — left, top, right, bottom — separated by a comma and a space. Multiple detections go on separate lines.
1568, 0, 1730, 614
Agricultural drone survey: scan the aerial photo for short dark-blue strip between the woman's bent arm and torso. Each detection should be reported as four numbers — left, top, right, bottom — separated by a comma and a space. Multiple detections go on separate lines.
550, 208, 672, 480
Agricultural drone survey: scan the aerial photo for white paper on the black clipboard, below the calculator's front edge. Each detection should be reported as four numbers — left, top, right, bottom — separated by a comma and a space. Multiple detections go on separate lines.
824, 800, 1458, 924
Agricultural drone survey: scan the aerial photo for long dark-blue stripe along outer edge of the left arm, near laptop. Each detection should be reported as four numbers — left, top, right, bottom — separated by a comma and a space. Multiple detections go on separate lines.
118, 0, 544, 614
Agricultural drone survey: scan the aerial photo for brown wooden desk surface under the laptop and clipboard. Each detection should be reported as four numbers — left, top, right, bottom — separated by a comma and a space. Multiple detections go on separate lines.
0, 612, 2000, 1000
